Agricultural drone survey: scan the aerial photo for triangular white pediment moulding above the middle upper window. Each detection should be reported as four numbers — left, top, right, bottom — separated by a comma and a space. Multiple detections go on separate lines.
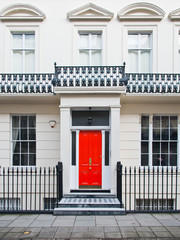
67, 3, 114, 21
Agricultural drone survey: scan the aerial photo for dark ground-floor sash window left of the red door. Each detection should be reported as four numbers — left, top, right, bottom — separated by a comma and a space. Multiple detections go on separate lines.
12, 116, 36, 166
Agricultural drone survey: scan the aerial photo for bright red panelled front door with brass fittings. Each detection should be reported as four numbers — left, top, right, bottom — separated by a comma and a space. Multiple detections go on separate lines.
79, 131, 102, 188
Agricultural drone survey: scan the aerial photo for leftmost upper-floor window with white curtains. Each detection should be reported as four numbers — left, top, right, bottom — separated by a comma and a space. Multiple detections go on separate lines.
12, 33, 35, 73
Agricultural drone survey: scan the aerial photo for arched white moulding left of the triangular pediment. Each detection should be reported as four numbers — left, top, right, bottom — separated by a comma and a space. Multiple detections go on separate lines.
0, 4, 45, 21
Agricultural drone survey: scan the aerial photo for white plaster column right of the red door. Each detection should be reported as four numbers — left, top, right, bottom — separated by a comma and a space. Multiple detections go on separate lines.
110, 105, 121, 194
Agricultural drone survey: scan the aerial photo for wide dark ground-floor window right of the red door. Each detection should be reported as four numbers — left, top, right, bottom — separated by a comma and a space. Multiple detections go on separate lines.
141, 115, 178, 166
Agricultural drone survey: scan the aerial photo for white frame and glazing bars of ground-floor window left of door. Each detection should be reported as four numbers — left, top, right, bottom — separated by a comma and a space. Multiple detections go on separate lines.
11, 114, 37, 168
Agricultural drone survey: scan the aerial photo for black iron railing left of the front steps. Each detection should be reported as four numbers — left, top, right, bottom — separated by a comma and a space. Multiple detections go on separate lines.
0, 163, 63, 213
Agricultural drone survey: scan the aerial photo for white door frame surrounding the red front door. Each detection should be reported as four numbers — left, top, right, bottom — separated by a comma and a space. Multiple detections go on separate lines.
70, 126, 111, 190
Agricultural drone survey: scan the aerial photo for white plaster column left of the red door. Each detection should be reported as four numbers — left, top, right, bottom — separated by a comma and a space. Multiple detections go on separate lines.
59, 105, 71, 194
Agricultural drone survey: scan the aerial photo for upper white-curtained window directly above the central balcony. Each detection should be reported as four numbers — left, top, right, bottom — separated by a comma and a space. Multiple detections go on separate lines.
79, 33, 102, 66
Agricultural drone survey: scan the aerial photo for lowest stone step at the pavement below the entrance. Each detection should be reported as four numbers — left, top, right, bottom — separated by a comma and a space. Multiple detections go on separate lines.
53, 208, 125, 215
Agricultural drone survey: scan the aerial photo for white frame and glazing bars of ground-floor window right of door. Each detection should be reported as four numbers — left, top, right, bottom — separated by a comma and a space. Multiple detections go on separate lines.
140, 114, 180, 168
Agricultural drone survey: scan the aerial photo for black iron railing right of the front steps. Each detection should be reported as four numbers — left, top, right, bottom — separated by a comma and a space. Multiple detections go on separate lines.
117, 162, 180, 212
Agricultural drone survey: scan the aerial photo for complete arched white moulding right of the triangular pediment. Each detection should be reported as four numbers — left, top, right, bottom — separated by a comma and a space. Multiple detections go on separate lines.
117, 2, 165, 20
